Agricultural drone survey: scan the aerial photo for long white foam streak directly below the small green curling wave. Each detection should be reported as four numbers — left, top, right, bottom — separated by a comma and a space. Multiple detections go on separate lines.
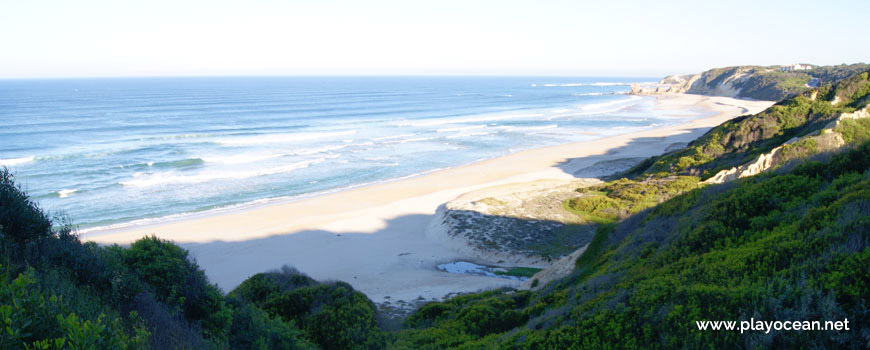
120, 158, 326, 187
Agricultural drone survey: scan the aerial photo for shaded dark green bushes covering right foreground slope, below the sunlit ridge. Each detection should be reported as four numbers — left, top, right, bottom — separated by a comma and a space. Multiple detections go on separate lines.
394, 144, 870, 349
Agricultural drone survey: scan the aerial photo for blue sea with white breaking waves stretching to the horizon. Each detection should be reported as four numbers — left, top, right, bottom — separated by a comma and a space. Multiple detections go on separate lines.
0, 77, 700, 231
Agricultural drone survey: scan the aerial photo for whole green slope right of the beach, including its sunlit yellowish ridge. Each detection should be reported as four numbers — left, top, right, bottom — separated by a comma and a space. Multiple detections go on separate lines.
391, 73, 870, 349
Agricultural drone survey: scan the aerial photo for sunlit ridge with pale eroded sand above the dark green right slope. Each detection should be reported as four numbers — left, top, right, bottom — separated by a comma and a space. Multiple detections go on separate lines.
623, 72, 870, 182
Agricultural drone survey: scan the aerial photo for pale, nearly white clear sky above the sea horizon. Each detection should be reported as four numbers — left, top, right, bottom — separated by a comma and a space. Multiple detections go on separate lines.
0, 0, 870, 78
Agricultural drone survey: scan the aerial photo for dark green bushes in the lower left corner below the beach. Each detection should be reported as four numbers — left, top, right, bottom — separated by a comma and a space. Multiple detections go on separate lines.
0, 169, 384, 349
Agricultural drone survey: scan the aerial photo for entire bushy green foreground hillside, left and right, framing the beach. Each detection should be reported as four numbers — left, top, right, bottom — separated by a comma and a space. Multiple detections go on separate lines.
0, 71, 870, 349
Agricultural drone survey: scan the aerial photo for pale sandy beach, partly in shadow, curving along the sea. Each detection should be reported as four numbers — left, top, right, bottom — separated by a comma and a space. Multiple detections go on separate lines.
82, 94, 772, 303
